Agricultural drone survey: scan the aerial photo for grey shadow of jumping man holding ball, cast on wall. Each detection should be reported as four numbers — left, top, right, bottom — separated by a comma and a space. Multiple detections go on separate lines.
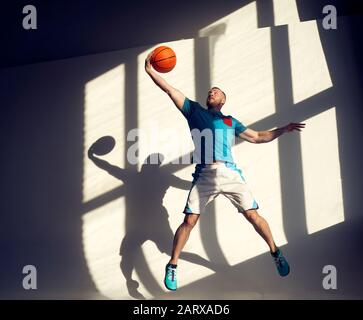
88, 136, 219, 299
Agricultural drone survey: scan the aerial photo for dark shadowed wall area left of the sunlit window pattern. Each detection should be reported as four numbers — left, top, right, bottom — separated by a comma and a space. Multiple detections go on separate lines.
0, 54, 129, 299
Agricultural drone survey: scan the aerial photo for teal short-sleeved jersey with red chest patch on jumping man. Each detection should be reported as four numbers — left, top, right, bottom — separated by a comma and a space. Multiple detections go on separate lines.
181, 98, 247, 164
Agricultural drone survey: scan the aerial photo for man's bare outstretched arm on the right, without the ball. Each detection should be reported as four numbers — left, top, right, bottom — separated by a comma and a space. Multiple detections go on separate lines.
238, 122, 305, 143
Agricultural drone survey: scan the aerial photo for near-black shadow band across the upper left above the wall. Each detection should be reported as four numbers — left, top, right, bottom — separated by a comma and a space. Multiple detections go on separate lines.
0, 0, 252, 67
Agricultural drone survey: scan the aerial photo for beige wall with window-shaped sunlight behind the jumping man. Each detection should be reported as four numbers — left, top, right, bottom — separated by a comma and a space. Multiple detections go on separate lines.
2, 1, 362, 299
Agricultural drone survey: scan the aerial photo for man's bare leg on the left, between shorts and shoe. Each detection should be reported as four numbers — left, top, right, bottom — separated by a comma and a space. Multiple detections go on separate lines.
169, 213, 199, 264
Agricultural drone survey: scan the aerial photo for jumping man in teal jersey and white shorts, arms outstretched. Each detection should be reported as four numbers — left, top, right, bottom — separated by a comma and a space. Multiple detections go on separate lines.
145, 52, 305, 290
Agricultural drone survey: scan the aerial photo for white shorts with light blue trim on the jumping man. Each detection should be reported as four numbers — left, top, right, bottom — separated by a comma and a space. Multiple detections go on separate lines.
183, 162, 259, 214
